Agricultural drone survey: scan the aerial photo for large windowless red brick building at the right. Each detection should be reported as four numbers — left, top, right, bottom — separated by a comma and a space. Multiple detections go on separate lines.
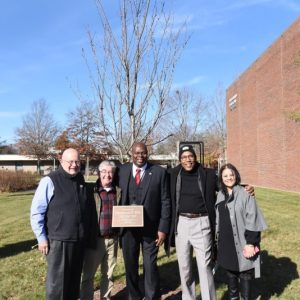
226, 18, 300, 192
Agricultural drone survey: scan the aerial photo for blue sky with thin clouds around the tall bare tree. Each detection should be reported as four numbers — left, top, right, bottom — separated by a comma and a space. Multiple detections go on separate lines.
0, 0, 300, 143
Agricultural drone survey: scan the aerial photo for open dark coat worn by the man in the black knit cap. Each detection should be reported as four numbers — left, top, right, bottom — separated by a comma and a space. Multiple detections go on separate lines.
167, 163, 218, 250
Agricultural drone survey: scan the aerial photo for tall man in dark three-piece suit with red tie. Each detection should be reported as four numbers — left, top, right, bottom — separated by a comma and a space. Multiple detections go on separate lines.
119, 143, 170, 300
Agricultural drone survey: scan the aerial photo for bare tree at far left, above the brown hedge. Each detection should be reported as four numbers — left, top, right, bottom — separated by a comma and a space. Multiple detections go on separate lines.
16, 99, 58, 173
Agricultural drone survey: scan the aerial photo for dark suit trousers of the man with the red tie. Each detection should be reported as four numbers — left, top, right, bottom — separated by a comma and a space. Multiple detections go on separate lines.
122, 228, 160, 300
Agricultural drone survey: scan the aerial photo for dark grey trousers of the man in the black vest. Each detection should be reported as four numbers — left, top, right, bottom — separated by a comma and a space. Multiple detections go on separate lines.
46, 240, 84, 300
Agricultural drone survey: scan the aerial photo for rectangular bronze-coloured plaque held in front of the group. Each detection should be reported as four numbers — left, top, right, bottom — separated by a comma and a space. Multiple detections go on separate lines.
112, 205, 144, 227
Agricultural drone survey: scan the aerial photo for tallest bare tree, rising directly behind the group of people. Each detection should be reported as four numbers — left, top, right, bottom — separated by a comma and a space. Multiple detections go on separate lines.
83, 0, 188, 161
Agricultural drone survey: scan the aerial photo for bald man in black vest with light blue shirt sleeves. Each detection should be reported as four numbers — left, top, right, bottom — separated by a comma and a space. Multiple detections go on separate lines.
30, 148, 89, 300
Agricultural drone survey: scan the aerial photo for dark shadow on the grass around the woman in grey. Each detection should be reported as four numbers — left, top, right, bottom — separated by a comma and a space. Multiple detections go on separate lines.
217, 251, 299, 300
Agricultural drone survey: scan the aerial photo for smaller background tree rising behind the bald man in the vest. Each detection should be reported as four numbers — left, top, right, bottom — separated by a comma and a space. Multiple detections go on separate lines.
65, 101, 108, 176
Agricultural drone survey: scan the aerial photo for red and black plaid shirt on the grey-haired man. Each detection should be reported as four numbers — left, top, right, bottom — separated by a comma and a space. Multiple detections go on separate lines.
99, 187, 117, 237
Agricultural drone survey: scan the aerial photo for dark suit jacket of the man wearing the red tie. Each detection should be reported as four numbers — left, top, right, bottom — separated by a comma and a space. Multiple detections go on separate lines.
119, 163, 171, 239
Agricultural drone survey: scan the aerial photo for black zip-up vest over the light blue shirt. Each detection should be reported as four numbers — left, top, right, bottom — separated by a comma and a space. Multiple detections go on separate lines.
46, 167, 86, 241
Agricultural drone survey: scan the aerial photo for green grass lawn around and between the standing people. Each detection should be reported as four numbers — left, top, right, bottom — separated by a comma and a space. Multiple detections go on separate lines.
0, 188, 300, 300
